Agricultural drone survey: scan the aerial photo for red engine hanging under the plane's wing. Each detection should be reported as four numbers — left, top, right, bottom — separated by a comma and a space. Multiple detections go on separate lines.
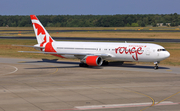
81, 56, 103, 66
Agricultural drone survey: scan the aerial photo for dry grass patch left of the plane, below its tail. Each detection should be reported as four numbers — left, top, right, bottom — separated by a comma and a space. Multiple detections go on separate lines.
0, 39, 61, 59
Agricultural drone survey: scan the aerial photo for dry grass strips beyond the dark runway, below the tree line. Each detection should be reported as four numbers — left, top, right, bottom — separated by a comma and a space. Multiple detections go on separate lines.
0, 27, 180, 39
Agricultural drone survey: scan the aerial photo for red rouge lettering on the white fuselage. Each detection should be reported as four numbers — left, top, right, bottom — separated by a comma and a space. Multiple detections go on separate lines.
115, 47, 143, 61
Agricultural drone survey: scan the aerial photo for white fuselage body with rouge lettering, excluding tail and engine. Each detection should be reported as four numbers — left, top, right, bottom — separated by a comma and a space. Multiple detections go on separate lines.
52, 41, 170, 62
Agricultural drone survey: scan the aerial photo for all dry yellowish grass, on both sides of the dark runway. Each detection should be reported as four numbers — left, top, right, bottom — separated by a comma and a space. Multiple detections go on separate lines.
0, 27, 180, 66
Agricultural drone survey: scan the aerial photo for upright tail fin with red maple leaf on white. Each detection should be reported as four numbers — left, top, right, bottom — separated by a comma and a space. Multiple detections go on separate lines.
30, 15, 54, 46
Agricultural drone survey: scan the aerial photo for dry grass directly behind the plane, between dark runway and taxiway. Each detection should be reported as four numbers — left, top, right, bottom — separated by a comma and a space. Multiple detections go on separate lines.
0, 39, 180, 66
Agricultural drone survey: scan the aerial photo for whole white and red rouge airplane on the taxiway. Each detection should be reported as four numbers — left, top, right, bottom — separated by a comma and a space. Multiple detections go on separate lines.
19, 15, 170, 69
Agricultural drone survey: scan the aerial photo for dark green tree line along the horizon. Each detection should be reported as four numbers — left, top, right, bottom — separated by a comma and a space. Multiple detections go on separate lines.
0, 13, 180, 27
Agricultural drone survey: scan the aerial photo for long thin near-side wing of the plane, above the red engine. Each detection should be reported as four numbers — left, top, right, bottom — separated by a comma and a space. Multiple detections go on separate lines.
18, 51, 111, 57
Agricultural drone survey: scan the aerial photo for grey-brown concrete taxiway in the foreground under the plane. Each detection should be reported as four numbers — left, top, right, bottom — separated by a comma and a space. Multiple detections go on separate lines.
0, 58, 180, 111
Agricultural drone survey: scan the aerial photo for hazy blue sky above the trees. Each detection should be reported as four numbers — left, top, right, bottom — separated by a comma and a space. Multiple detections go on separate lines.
0, 0, 180, 15
